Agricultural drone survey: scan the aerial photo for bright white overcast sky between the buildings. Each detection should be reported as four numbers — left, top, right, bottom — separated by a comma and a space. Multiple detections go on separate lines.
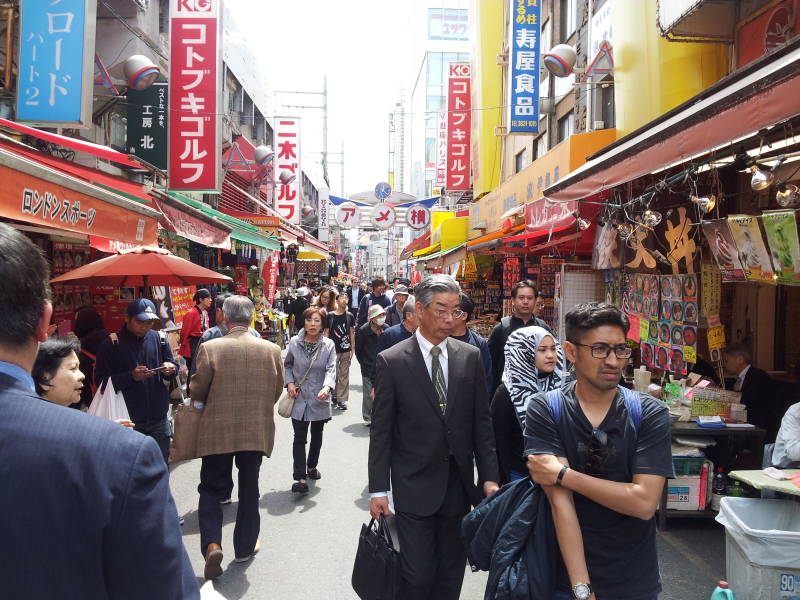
226, 0, 425, 196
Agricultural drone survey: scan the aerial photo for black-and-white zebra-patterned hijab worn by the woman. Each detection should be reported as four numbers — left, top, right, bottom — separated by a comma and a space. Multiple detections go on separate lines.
503, 326, 566, 431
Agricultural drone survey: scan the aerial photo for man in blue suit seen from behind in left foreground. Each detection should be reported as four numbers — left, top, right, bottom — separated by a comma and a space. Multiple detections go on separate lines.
0, 224, 200, 600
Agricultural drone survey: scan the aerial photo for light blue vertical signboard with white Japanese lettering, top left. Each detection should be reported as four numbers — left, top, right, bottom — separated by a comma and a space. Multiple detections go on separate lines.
17, 0, 97, 128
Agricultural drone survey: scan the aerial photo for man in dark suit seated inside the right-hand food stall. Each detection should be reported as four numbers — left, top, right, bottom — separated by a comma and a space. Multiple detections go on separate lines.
722, 344, 783, 443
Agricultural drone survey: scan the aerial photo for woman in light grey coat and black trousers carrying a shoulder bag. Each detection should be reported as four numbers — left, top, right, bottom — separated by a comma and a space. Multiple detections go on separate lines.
284, 306, 336, 494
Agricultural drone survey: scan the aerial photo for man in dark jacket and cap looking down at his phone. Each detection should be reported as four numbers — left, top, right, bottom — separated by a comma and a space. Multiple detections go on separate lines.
94, 298, 177, 462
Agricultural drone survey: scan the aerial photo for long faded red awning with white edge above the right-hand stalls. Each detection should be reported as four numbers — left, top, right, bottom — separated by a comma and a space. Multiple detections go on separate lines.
544, 37, 800, 201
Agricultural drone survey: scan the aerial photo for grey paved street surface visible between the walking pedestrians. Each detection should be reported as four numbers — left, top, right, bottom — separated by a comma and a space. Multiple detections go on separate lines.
171, 361, 725, 600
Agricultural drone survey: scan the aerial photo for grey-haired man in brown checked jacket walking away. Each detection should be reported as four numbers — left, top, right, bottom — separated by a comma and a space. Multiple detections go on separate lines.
189, 296, 283, 579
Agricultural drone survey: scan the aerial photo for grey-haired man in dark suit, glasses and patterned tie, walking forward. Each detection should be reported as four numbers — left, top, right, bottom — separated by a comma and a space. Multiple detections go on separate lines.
369, 275, 498, 600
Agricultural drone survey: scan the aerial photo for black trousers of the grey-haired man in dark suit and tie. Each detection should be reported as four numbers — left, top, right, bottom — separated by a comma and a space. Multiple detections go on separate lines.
396, 458, 469, 600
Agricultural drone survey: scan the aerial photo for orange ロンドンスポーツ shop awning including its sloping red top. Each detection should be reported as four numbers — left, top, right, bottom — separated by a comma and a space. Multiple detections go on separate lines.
0, 148, 161, 245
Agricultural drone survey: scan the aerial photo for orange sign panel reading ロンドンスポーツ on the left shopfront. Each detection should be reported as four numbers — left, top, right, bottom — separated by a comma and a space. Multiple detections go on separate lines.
0, 166, 157, 245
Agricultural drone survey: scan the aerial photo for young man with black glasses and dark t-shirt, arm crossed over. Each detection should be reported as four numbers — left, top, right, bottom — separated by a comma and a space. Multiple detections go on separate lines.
525, 302, 673, 600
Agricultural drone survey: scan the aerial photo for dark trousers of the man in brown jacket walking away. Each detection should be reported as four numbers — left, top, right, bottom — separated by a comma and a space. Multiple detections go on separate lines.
197, 451, 264, 558
